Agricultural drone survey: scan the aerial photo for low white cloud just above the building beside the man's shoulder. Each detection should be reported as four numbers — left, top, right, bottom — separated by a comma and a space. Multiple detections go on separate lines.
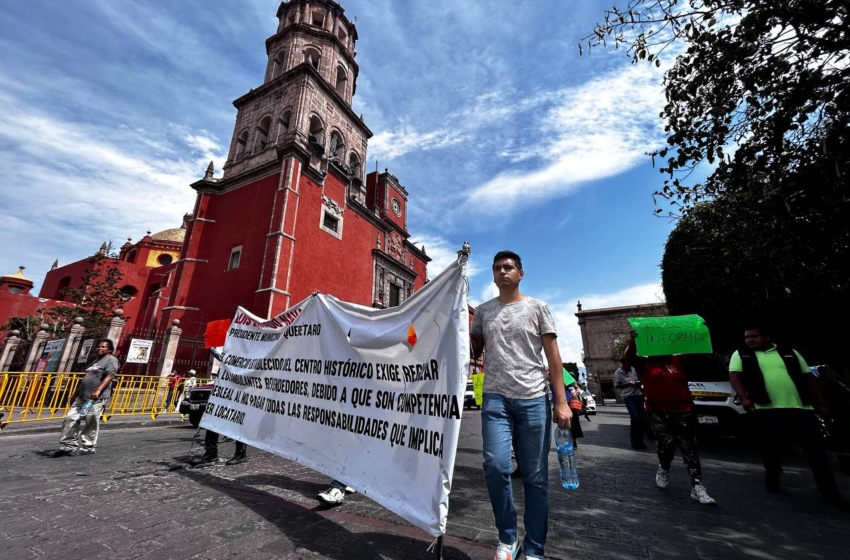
547, 282, 664, 364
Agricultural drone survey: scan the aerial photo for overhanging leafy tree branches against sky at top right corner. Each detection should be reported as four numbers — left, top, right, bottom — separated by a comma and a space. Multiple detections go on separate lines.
584, 0, 850, 219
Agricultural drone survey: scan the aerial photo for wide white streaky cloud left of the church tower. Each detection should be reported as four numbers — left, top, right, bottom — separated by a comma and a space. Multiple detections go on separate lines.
0, 91, 224, 290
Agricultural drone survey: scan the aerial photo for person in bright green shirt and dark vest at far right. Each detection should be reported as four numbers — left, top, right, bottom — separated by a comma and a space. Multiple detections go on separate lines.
729, 326, 850, 510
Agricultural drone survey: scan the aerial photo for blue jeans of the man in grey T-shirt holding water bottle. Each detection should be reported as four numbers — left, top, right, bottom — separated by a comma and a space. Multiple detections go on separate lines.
481, 393, 552, 558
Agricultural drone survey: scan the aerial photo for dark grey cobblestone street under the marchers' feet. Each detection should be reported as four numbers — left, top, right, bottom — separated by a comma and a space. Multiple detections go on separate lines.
0, 406, 850, 560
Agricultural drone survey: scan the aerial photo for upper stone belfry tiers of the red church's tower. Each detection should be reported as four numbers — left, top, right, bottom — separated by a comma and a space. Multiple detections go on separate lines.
224, 0, 372, 203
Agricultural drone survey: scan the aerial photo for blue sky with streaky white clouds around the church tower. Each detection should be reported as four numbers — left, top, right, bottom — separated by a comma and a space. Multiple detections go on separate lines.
0, 0, 673, 361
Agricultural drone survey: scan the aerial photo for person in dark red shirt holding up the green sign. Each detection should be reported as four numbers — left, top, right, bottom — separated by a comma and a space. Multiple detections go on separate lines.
623, 331, 716, 506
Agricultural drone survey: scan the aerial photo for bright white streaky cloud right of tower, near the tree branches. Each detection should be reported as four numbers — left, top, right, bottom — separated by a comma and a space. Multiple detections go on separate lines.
468, 65, 664, 214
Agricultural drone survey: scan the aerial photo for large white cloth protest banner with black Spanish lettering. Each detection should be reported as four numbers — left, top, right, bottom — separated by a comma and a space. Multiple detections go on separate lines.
201, 259, 469, 536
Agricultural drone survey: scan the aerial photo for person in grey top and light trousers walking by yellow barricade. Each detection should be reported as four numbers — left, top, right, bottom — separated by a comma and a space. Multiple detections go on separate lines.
53, 338, 121, 457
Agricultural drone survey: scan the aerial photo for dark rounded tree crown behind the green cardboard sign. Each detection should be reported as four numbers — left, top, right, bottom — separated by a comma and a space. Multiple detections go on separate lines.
661, 203, 850, 365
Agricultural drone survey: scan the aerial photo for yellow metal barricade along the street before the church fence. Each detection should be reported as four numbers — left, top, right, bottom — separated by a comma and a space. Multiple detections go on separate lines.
0, 372, 207, 429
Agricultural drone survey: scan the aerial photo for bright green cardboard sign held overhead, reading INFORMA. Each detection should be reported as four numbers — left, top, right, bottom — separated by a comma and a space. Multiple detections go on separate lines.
629, 315, 712, 356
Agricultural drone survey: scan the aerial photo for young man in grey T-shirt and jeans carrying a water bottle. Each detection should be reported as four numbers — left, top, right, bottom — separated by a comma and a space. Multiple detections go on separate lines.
470, 251, 571, 560
